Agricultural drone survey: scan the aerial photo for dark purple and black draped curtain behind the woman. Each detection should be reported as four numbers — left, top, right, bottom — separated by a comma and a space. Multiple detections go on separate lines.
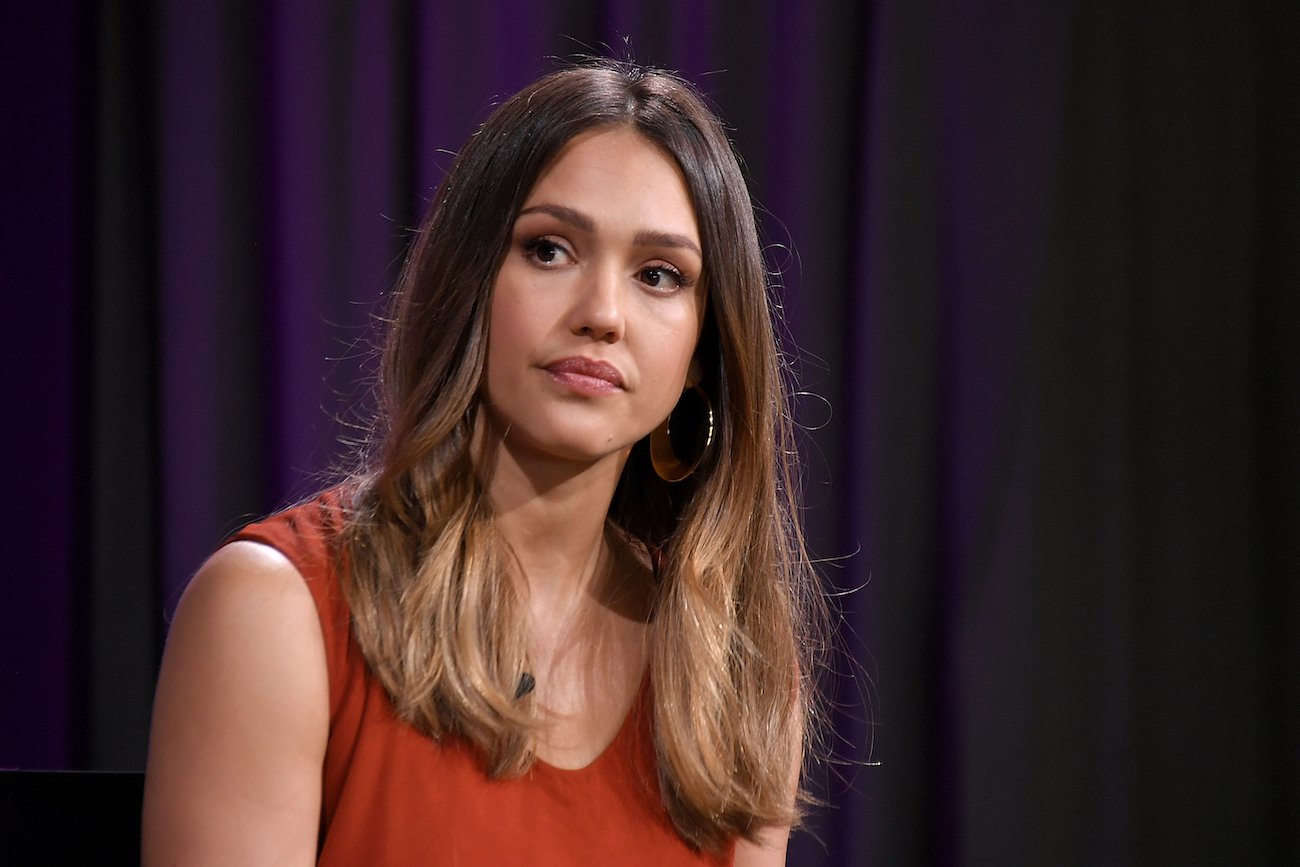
0, 0, 1300, 864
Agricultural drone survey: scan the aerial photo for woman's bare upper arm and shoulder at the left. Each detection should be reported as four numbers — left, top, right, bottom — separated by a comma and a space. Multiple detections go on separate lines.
143, 542, 329, 864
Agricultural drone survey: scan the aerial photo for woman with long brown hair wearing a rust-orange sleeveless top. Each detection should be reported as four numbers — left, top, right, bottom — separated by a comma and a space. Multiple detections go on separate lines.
144, 62, 818, 864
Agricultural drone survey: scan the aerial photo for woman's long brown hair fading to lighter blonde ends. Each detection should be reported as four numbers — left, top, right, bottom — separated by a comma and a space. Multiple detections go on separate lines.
343, 61, 823, 848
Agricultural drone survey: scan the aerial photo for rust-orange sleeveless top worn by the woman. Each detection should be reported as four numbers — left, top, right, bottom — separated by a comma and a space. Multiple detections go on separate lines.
233, 491, 735, 867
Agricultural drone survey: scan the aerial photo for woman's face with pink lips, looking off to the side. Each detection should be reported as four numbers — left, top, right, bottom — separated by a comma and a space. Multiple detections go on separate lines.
485, 123, 705, 463
